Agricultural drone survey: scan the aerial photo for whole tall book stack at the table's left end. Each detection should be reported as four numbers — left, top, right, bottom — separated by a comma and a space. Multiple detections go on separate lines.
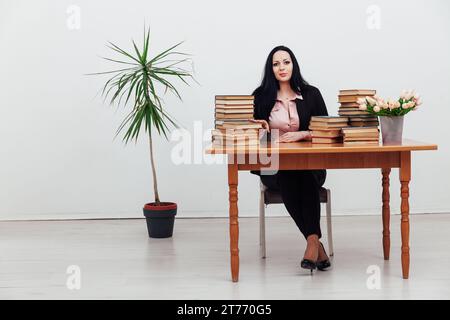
212, 95, 262, 146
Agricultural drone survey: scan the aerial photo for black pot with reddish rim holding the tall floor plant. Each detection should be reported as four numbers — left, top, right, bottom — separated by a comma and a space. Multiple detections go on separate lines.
144, 202, 177, 238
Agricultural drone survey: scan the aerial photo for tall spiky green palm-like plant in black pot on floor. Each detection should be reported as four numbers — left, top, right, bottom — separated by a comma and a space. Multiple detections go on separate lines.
93, 28, 195, 238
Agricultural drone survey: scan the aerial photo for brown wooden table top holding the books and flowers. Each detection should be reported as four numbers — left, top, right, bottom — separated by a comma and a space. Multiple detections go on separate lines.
205, 139, 438, 154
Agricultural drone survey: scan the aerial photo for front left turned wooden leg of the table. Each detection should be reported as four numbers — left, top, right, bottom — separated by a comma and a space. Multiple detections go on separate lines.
228, 163, 239, 282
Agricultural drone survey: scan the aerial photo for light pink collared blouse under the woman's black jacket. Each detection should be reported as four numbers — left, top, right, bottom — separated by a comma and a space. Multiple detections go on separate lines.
269, 94, 303, 136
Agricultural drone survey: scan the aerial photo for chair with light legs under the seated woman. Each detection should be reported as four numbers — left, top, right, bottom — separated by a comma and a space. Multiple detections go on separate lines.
259, 180, 334, 259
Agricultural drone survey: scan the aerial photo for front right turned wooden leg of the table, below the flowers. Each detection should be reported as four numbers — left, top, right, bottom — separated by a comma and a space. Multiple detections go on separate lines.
400, 151, 411, 279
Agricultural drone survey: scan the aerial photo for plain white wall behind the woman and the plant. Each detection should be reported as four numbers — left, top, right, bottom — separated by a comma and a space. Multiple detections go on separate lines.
0, 0, 450, 219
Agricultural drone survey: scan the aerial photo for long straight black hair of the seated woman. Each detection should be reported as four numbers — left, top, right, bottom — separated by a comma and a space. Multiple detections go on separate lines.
252, 46, 308, 120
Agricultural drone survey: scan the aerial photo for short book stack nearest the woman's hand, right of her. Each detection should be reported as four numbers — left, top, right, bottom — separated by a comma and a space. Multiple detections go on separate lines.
309, 116, 348, 144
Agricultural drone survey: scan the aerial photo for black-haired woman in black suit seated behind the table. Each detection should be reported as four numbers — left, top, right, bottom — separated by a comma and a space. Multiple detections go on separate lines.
251, 46, 331, 272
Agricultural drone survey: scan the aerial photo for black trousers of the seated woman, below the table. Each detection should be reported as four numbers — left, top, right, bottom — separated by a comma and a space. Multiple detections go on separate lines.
261, 170, 324, 239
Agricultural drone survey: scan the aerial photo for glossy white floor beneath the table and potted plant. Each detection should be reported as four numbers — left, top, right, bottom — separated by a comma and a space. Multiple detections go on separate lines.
0, 214, 450, 299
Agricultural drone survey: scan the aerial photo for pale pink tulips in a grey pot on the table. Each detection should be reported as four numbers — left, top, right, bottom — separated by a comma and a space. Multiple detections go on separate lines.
358, 90, 422, 144
